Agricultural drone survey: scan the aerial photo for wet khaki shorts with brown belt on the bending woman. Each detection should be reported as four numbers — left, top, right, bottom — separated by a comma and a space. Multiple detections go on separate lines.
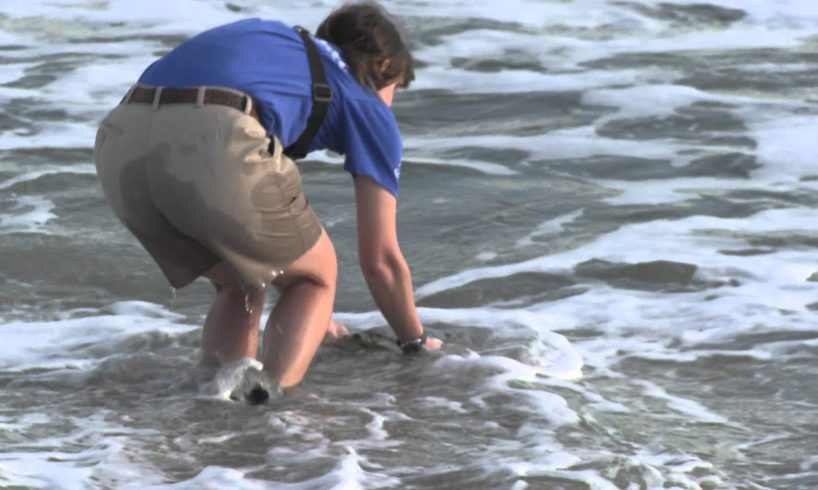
94, 89, 321, 294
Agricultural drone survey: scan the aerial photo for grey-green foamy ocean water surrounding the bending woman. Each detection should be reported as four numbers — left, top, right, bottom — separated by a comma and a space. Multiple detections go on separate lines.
0, 0, 818, 490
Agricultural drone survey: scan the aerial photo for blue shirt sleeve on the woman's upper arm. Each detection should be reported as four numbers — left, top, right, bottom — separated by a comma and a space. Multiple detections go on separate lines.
342, 98, 403, 197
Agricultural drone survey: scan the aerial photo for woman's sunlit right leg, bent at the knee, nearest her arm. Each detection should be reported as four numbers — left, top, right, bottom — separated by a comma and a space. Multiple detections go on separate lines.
264, 232, 338, 388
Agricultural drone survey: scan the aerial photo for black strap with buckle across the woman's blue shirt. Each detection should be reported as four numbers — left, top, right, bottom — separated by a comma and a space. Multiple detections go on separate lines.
284, 26, 332, 159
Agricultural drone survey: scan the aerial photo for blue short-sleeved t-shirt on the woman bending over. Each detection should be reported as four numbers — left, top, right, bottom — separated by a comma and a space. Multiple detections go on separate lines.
139, 19, 403, 196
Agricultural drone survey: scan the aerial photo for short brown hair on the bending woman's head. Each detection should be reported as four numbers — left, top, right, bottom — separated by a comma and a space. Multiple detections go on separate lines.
315, 1, 415, 91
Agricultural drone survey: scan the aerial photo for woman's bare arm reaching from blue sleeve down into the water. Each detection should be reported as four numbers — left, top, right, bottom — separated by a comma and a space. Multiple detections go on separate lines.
355, 175, 442, 349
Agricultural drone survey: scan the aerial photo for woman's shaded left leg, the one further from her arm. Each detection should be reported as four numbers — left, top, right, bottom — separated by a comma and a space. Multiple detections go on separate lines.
202, 264, 264, 363
